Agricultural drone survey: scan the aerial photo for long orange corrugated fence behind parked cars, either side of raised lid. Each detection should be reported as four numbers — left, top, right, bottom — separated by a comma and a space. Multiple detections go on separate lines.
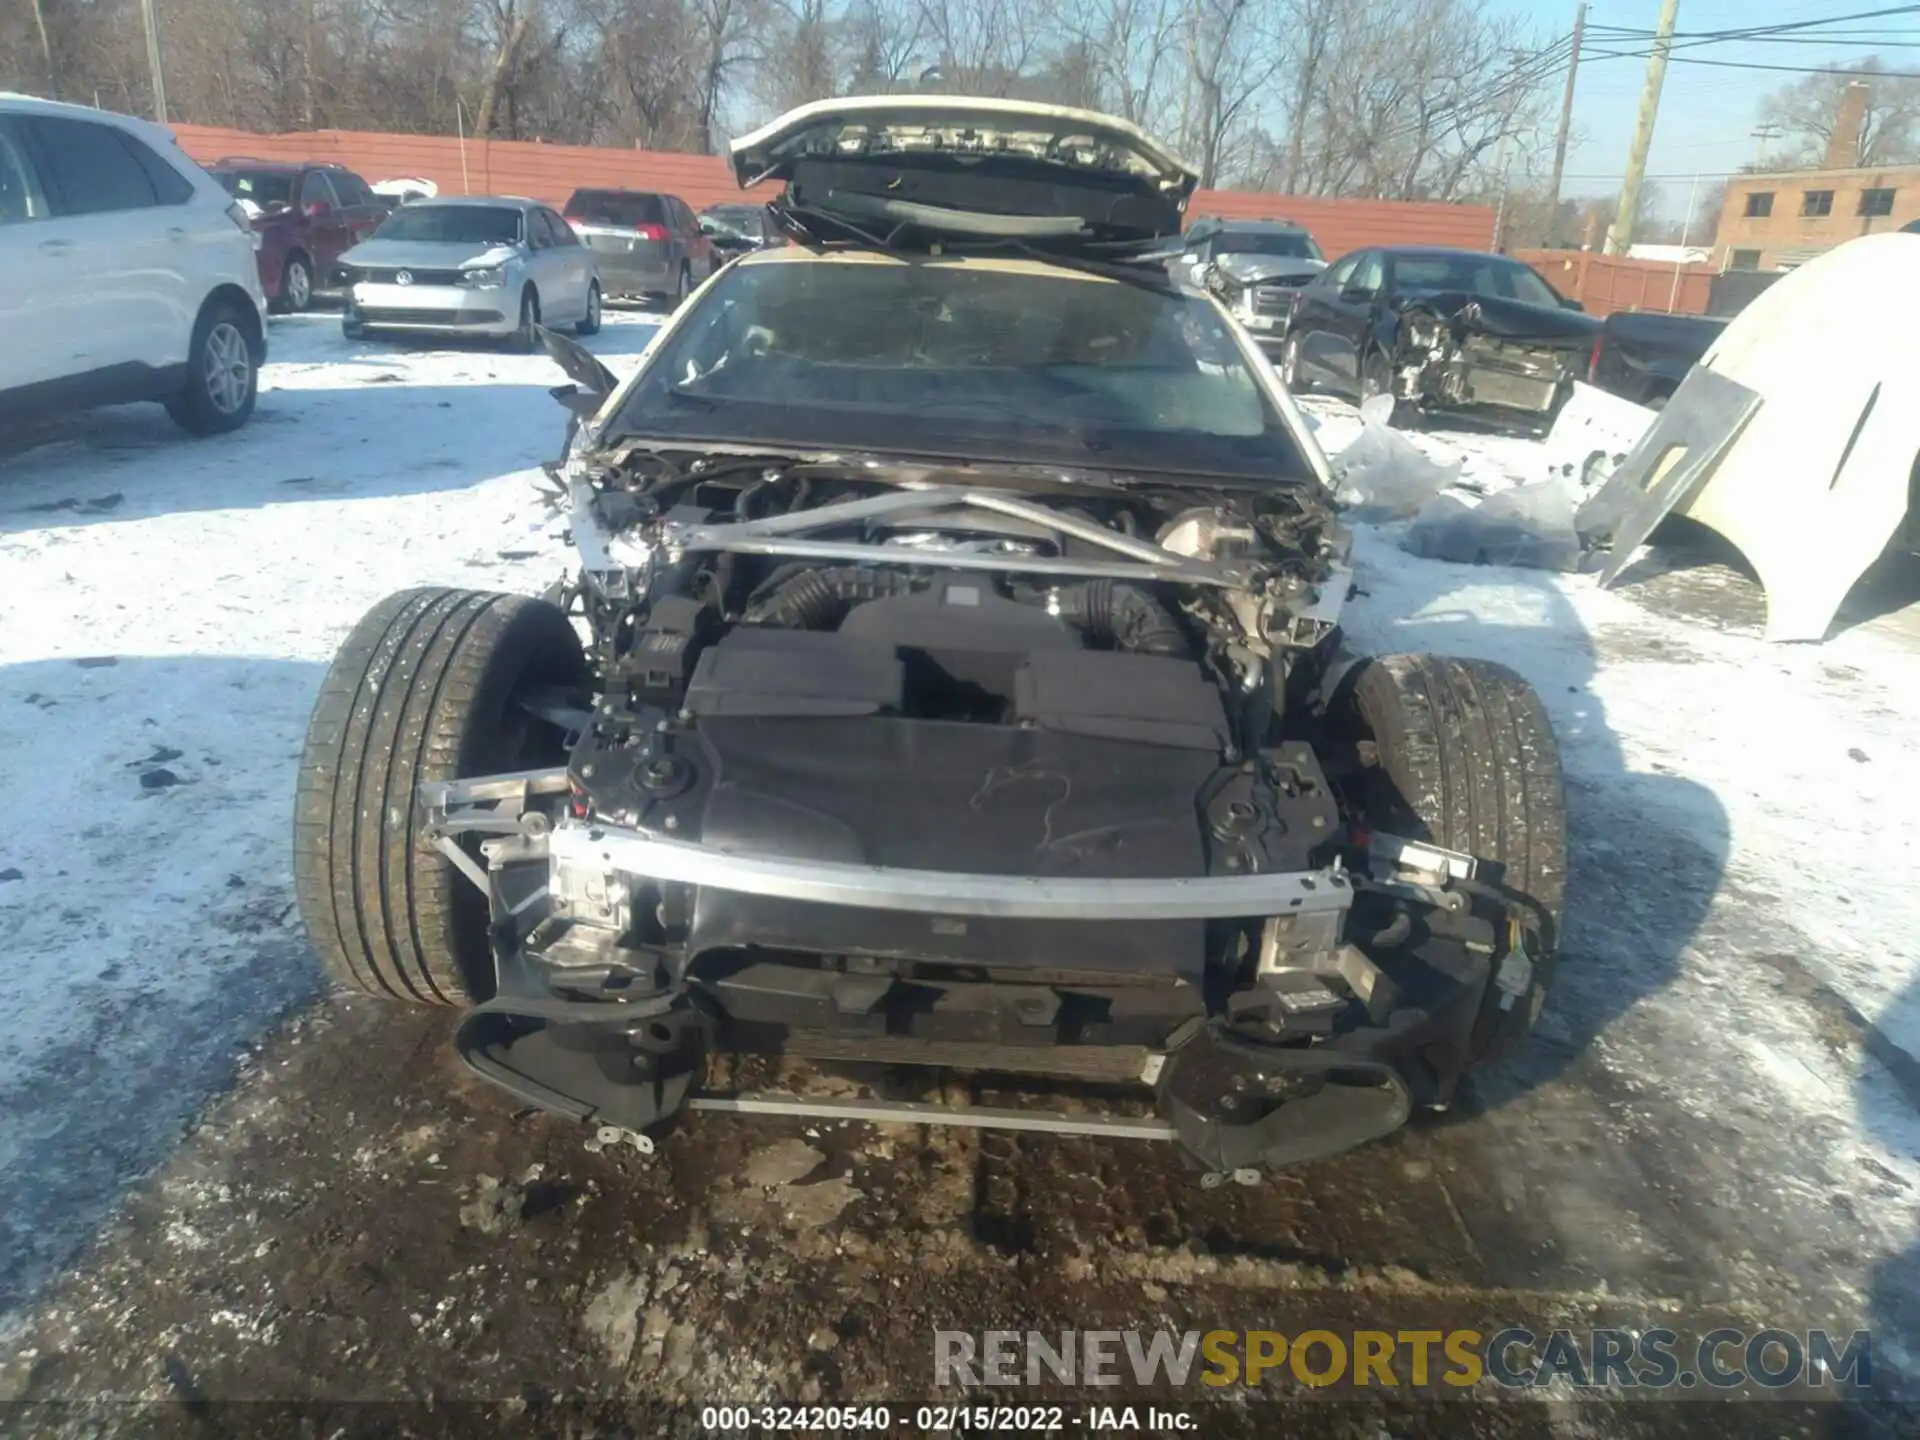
173, 125, 1494, 259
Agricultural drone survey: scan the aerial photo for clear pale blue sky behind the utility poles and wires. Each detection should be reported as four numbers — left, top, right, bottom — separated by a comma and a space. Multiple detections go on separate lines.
1507, 0, 1920, 219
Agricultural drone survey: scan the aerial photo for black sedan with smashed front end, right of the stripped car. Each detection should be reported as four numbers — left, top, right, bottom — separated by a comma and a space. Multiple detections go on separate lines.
1281, 246, 1599, 428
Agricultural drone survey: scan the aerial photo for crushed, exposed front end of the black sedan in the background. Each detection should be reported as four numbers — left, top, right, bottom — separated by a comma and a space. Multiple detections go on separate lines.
1390, 294, 1599, 426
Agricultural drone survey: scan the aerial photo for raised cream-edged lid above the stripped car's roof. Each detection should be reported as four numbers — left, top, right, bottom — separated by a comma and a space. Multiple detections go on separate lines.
732, 96, 1200, 242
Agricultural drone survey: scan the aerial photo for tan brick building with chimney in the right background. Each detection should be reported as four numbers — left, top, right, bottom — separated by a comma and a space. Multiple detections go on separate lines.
1713, 83, 1920, 271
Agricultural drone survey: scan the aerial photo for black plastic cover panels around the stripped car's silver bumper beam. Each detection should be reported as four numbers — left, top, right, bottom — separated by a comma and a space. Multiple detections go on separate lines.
574, 630, 1334, 979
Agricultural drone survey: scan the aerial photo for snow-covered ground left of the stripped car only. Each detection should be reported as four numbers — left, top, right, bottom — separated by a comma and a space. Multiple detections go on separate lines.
0, 313, 657, 1313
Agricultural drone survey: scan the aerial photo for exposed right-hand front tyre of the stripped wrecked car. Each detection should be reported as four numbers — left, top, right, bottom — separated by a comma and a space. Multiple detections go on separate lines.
1329, 655, 1567, 1060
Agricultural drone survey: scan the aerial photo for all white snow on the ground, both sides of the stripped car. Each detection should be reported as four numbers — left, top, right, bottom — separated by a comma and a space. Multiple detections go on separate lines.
0, 324, 1920, 1374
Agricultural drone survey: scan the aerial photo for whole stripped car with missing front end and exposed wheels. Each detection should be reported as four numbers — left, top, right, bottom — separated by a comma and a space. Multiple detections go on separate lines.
296, 96, 1565, 1183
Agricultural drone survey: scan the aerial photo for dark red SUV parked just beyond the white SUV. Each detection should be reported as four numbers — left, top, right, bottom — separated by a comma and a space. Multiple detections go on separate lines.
207, 157, 392, 313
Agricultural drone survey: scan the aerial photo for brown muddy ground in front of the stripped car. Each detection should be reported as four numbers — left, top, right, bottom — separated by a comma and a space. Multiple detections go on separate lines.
0, 1002, 1903, 1440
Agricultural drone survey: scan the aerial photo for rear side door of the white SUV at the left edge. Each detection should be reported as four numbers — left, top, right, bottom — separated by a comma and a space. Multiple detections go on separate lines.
15, 115, 183, 374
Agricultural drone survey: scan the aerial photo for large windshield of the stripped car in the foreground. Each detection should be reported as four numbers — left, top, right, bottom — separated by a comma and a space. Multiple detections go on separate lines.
607, 259, 1308, 480
